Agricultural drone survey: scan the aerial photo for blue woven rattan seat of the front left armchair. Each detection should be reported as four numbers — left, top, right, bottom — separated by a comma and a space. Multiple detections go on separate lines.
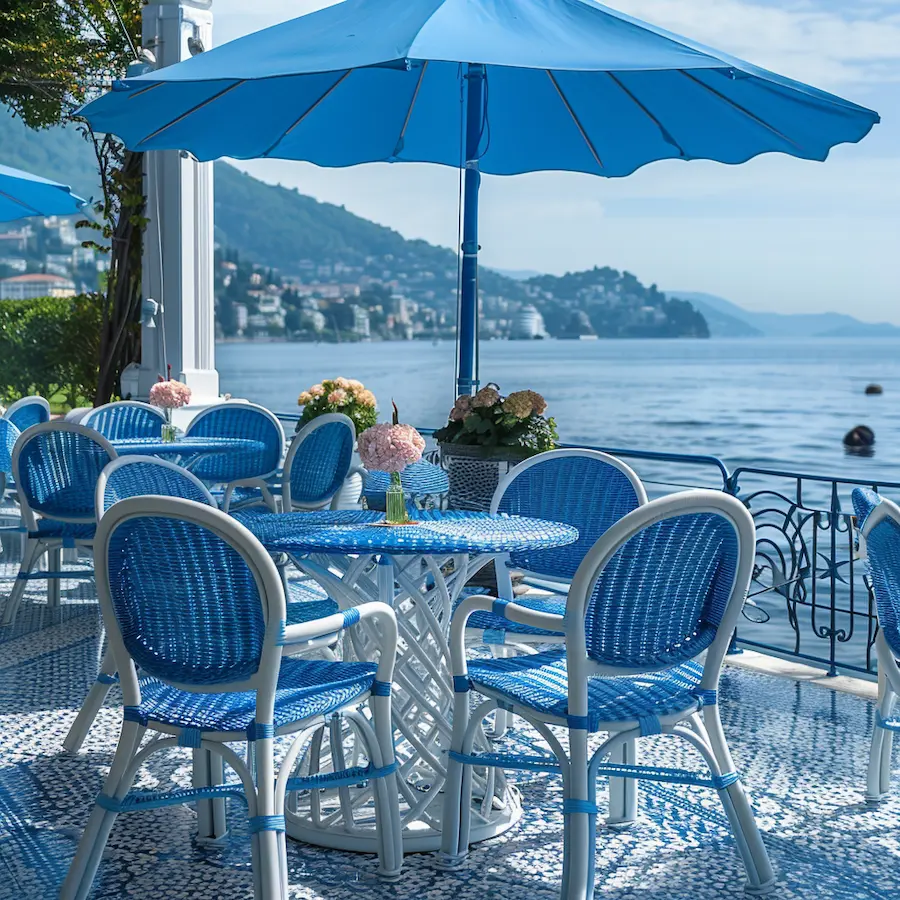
125, 658, 376, 736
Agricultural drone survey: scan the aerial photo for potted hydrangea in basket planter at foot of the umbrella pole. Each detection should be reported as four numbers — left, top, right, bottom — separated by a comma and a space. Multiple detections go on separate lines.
434, 383, 558, 510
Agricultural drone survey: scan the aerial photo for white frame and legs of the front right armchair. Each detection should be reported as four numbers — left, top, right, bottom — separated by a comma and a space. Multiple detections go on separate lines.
441, 490, 775, 900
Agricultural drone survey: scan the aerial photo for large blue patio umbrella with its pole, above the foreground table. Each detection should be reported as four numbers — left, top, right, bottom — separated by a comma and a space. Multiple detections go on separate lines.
82, 0, 878, 392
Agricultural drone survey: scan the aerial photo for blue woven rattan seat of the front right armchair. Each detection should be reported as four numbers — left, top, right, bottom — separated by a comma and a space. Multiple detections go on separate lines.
469, 648, 703, 731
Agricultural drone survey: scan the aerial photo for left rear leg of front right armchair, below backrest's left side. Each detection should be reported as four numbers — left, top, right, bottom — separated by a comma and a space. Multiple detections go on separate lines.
560, 728, 596, 900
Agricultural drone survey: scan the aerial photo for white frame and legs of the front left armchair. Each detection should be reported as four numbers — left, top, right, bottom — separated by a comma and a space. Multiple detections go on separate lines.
60, 496, 403, 900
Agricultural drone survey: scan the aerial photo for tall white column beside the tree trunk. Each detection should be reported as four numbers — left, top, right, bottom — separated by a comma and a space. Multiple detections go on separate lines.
138, 0, 219, 405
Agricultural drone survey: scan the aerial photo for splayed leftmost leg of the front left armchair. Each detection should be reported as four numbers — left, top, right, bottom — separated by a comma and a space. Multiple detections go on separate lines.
59, 722, 144, 900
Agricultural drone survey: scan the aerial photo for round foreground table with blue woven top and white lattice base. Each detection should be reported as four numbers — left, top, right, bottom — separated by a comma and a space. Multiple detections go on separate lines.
235, 510, 578, 852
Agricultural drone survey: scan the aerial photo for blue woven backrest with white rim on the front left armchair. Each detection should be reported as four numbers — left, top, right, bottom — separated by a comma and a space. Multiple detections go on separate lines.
94, 497, 285, 692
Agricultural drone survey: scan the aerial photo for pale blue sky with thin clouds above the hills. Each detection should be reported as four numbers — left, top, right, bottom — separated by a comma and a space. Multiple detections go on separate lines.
213, 0, 900, 324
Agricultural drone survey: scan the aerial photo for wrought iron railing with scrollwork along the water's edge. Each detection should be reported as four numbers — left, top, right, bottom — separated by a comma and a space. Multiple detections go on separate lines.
283, 416, 900, 677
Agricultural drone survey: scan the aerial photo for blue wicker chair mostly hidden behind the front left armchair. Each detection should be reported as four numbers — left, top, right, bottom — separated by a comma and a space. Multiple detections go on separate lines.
63, 456, 339, 753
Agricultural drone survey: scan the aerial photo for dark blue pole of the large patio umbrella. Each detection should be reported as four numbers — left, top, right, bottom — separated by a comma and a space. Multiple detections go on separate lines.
456, 63, 485, 394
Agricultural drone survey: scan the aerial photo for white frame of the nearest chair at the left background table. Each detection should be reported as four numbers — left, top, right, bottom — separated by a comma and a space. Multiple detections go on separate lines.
0, 420, 118, 625
